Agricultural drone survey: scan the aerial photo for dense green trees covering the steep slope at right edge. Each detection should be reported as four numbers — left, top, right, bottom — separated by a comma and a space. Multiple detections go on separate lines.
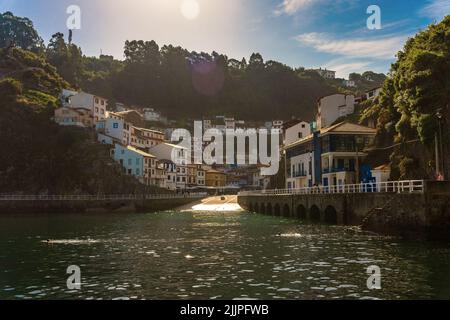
362, 16, 450, 178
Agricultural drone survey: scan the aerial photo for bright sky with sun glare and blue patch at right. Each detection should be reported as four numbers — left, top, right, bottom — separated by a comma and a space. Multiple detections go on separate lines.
0, 0, 450, 78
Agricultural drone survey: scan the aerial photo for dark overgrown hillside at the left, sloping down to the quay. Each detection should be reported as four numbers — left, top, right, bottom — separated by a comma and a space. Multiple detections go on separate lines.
0, 49, 156, 194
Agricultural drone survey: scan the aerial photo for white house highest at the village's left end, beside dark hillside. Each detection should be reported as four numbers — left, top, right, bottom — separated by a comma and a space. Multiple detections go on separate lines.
61, 89, 108, 123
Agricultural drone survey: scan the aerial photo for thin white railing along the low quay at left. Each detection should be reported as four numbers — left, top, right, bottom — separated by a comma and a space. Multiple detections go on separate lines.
0, 193, 208, 201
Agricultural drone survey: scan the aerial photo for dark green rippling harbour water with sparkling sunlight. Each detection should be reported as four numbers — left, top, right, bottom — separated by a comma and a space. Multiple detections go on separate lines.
0, 212, 450, 299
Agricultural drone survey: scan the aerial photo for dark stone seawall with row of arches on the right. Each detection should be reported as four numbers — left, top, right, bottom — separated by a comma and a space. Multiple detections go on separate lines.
238, 182, 450, 239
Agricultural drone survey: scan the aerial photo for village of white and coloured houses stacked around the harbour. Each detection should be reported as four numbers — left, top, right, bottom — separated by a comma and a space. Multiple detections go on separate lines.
54, 69, 384, 192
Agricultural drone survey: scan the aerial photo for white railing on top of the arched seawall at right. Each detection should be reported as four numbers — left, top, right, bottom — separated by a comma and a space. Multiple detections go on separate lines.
239, 180, 425, 196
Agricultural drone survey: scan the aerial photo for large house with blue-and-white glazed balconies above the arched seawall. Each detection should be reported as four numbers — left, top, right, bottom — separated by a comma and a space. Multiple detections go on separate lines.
285, 122, 376, 189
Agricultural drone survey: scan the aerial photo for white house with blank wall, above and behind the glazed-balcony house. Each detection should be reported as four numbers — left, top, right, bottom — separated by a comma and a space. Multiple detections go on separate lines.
317, 93, 355, 130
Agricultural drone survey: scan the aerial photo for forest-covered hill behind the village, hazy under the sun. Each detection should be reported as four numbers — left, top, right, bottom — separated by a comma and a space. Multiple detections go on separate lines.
0, 12, 385, 121
